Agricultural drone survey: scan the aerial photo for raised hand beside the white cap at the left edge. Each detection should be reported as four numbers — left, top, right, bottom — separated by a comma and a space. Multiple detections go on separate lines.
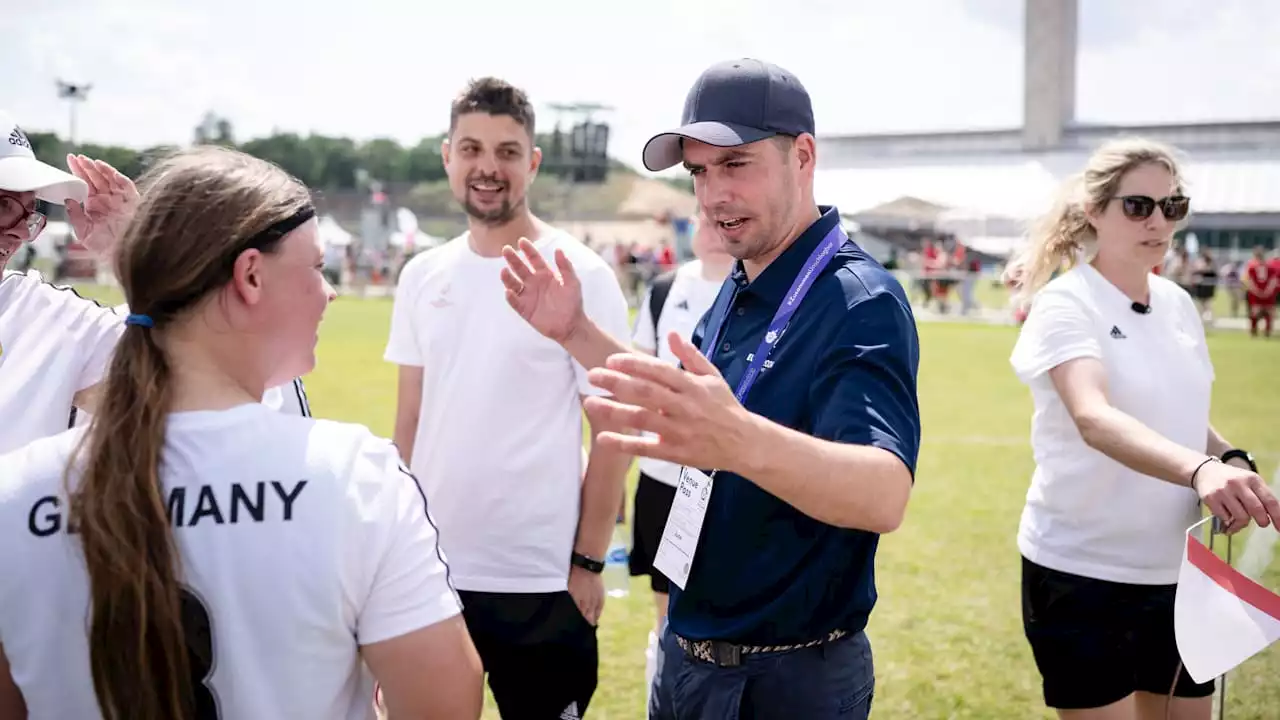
67, 155, 138, 258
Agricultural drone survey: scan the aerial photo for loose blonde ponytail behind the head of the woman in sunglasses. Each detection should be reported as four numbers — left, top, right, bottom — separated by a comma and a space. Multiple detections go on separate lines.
1002, 176, 1094, 307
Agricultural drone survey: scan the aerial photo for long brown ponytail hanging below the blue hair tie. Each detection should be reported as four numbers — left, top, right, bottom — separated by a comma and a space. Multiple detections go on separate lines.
69, 325, 193, 720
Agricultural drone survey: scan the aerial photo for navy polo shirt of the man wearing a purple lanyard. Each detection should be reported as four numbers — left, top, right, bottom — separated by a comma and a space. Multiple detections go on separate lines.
669, 208, 920, 644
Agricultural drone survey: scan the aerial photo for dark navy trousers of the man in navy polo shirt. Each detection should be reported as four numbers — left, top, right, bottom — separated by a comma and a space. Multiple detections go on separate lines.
649, 620, 876, 720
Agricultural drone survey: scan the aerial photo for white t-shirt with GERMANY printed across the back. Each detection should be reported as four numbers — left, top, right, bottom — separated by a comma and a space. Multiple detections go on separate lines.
0, 405, 460, 720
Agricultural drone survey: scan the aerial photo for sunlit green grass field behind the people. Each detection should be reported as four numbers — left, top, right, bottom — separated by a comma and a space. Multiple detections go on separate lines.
80, 283, 1280, 720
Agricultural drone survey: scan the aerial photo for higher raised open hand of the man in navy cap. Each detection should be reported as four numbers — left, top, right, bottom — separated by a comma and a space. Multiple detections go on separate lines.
502, 237, 586, 343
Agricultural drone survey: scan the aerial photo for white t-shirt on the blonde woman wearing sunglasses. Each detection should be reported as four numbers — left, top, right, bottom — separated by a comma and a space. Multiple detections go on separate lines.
1011, 264, 1213, 584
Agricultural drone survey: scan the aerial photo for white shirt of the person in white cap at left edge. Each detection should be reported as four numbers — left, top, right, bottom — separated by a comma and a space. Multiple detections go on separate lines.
0, 270, 124, 454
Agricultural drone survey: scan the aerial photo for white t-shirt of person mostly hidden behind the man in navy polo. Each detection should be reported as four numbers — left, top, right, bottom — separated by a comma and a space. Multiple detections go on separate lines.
631, 260, 724, 487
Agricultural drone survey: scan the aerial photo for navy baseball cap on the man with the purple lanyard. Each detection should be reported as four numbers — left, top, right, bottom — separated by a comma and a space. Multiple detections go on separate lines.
644, 58, 814, 172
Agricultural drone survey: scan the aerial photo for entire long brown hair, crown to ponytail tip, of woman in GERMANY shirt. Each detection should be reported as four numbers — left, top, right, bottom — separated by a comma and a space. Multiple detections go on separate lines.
56, 146, 314, 720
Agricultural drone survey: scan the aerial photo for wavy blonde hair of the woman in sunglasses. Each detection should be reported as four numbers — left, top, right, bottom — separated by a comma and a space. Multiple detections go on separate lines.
1004, 137, 1181, 305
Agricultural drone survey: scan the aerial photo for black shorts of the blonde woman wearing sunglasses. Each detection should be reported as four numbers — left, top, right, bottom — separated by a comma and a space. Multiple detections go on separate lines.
1023, 557, 1213, 710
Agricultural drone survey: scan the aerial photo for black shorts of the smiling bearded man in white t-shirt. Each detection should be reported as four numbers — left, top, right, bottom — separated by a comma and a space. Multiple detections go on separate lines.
458, 591, 599, 720
